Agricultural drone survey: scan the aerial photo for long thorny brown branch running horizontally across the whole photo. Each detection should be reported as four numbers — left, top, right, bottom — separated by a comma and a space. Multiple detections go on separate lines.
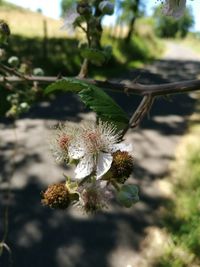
0, 75, 200, 96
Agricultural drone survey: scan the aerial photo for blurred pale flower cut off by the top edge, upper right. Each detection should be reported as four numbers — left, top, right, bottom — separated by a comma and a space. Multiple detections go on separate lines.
163, 0, 186, 18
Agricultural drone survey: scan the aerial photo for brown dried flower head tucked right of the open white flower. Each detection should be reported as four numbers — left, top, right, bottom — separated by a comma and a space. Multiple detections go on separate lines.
110, 150, 133, 183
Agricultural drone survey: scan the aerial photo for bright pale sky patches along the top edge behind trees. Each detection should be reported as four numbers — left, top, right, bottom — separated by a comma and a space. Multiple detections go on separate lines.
7, 0, 200, 31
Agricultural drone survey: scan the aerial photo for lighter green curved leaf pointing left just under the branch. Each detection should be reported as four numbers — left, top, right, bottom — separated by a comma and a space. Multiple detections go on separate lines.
44, 78, 88, 94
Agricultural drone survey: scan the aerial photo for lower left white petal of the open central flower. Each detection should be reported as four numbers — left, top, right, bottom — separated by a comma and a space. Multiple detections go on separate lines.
75, 156, 94, 179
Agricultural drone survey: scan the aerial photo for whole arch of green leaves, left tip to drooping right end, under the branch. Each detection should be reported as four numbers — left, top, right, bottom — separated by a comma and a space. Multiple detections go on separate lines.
45, 79, 128, 130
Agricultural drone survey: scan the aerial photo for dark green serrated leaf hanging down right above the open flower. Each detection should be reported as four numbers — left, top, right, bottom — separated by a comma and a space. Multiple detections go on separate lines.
78, 86, 128, 130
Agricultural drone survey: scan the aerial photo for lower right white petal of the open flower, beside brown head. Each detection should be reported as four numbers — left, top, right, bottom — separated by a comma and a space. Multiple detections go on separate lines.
97, 152, 113, 179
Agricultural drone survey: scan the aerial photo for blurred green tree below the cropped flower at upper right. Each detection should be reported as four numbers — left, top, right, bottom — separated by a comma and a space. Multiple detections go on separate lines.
154, 7, 194, 38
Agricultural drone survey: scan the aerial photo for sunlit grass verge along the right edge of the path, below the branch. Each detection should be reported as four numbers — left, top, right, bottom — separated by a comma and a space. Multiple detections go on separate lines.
153, 102, 200, 267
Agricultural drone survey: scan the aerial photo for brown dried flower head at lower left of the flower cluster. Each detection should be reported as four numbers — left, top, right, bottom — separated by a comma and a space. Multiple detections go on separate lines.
42, 183, 71, 209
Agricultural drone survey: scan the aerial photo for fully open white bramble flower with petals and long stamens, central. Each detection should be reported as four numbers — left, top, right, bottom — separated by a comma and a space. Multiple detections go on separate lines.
69, 121, 133, 180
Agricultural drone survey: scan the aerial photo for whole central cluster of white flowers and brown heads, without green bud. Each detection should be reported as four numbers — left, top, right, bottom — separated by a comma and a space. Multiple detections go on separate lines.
42, 121, 133, 213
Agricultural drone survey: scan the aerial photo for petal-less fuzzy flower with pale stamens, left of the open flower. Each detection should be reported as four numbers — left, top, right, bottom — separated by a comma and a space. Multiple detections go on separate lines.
50, 123, 79, 162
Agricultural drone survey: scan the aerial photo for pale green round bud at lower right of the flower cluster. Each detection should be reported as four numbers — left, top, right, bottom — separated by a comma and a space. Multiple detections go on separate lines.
117, 184, 139, 208
